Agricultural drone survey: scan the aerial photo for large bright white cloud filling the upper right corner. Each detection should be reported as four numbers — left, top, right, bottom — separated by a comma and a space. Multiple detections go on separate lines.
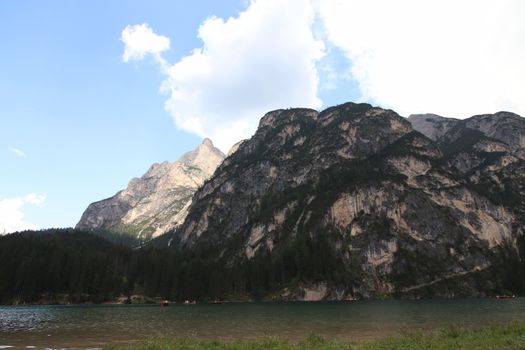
316, 0, 525, 118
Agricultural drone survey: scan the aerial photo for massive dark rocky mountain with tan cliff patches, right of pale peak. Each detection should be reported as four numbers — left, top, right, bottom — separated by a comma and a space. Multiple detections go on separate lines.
170, 103, 525, 299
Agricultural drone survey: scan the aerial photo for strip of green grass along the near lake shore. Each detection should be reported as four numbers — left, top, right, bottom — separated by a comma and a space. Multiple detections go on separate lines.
106, 323, 525, 350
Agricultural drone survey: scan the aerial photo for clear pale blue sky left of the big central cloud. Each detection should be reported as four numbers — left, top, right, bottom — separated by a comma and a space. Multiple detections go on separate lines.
0, 1, 250, 231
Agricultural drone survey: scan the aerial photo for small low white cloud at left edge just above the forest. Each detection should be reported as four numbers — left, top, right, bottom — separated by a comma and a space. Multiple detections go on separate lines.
0, 193, 46, 235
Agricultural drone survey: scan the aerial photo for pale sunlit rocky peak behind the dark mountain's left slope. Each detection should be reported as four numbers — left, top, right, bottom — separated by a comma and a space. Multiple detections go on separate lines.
76, 139, 224, 240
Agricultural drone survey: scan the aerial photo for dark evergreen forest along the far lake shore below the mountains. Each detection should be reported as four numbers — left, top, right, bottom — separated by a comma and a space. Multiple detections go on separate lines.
0, 229, 525, 304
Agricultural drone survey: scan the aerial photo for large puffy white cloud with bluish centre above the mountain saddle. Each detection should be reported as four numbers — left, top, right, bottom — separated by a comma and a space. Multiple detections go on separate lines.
125, 0, 324, 151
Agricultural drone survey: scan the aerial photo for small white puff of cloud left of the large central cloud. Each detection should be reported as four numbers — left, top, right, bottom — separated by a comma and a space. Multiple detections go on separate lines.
120, 23, 170, 63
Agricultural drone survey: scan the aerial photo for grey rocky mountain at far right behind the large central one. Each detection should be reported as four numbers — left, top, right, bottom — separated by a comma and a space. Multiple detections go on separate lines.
408, 112, 525, 205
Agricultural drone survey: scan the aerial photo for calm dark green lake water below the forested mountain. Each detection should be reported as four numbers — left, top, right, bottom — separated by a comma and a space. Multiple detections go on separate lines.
0, 298, 525, 349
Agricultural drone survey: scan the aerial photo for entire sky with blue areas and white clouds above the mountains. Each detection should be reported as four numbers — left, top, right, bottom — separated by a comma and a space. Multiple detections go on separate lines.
0, 0, 525, 234
